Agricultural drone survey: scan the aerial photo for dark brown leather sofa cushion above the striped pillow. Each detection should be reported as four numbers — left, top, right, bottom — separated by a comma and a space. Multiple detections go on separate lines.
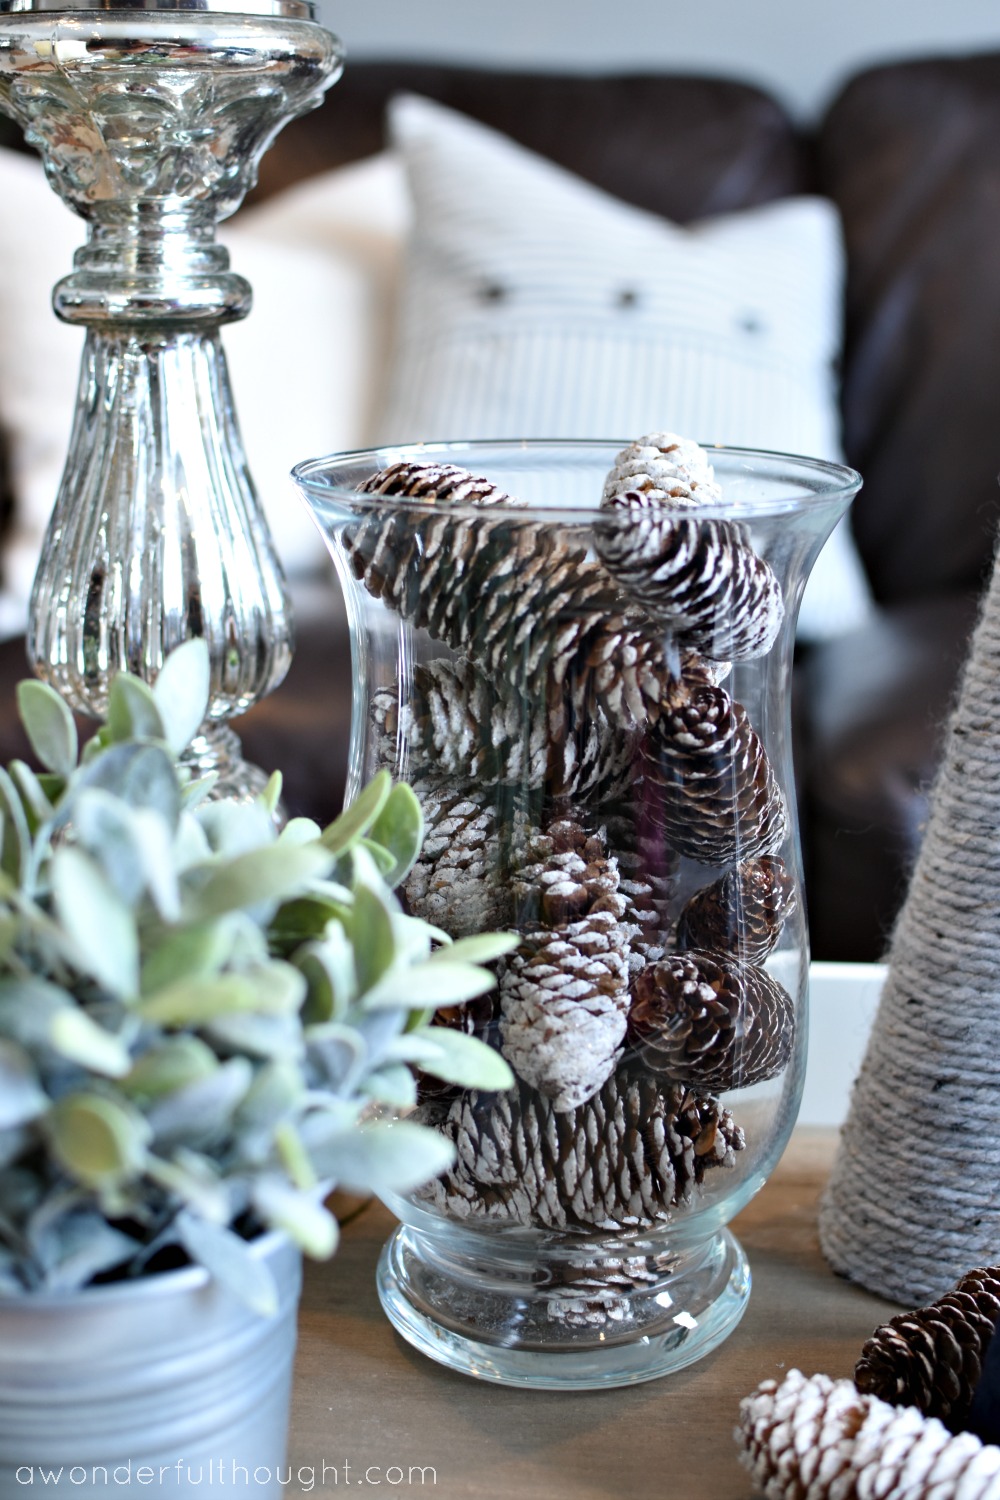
249, 63, 808, 224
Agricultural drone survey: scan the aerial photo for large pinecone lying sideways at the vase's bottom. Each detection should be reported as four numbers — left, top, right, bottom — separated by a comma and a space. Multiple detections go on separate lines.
412, 1068, 745, 1232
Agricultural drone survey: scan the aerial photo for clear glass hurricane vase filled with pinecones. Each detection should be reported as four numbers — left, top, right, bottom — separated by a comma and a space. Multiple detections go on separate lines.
295, 441, 861, 1388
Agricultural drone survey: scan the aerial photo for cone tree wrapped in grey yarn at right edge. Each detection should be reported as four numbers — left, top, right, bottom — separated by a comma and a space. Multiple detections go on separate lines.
820, 537, 1000, 1304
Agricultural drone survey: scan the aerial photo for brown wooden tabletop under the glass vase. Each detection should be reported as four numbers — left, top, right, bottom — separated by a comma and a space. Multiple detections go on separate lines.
286, 1128, 900, 1500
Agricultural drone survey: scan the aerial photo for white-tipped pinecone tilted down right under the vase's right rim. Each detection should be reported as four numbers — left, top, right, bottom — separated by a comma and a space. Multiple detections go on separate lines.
594, 491, 784, 662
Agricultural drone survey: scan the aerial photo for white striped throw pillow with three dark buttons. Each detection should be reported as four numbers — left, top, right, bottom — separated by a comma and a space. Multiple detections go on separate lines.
376, 95, 871, 638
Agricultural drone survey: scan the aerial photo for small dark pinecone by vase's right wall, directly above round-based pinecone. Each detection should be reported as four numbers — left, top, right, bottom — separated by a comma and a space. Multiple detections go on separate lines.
678, 855, 795, 963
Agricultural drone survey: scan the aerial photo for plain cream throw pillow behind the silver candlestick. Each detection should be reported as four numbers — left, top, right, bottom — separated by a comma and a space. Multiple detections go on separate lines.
0, 141, 408, 636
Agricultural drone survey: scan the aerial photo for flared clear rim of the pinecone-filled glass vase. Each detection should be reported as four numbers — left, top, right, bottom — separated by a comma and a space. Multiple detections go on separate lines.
291, 438, 864, 525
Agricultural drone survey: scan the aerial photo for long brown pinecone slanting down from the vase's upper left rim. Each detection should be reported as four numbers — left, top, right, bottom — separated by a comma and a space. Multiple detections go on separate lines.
346, 464, 705, 741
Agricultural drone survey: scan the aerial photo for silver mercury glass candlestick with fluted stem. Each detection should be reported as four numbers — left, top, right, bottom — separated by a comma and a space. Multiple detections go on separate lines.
0, 0, 342, 797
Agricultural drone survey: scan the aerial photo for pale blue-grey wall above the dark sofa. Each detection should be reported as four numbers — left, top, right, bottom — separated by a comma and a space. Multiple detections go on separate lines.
319, 0, 1000, 119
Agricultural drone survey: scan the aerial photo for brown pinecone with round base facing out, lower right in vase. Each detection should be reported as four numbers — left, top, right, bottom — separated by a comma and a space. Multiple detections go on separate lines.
628, 951, 795, 1094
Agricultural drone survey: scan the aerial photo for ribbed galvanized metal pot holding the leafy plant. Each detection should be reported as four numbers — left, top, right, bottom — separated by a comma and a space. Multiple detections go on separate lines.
0, 1235, 301, 1500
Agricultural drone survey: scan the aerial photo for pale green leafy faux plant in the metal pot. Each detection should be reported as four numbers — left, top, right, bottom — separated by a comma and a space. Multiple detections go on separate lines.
0, 641, 516, 1310
